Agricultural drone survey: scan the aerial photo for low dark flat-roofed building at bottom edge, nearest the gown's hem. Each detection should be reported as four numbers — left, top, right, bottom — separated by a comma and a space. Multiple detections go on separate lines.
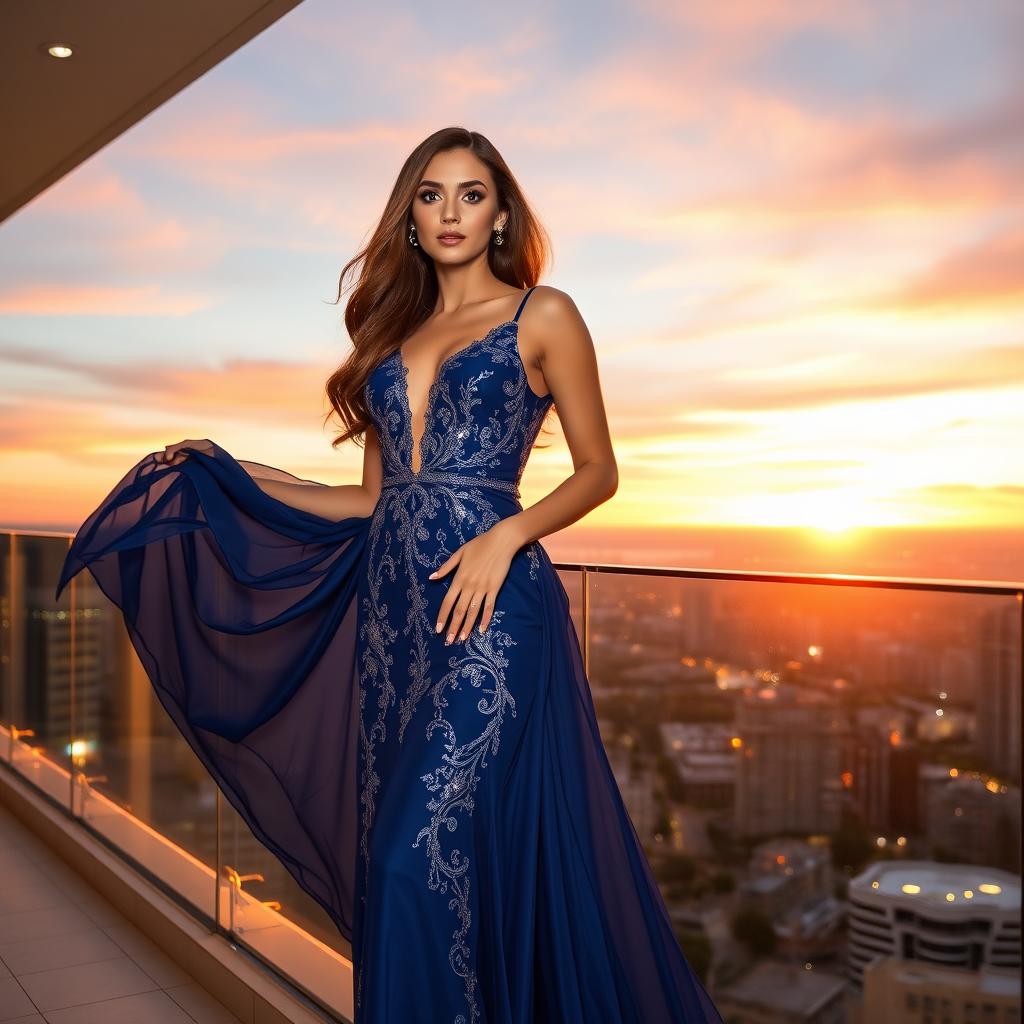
715, 961, 846, 1024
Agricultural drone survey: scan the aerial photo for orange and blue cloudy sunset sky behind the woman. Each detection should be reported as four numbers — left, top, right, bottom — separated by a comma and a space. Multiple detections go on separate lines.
0, 0, 1024, 529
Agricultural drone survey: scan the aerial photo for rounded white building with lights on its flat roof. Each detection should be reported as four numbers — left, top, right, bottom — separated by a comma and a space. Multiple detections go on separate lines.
847, 860, 1021, 987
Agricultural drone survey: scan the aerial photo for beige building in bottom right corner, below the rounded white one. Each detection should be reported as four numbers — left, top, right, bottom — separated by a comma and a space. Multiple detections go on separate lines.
863, 957, 1021, 1024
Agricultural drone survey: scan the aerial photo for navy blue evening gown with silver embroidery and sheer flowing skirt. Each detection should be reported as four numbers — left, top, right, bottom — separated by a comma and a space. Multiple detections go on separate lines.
57, 290, 721, 1024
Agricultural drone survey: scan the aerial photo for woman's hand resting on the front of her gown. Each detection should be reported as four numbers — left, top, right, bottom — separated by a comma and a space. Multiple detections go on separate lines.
430, 519, 521, 644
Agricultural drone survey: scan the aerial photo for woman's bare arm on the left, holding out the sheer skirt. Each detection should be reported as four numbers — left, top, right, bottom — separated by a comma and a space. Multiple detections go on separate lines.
157, 426, 383, 522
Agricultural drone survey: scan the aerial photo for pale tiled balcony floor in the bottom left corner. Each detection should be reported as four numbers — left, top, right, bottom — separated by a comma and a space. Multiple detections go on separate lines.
0, 807, 239, 1024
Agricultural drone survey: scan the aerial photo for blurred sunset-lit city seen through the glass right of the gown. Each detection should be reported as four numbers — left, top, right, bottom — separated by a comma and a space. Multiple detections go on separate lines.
590, 577, 1021, 1021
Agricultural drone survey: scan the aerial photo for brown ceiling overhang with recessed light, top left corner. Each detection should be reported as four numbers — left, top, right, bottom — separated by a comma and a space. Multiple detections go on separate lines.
0, 0, 301, 221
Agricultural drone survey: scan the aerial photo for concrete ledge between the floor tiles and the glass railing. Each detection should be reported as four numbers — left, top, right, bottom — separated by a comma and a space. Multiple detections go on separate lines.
0, 764, 350, 1024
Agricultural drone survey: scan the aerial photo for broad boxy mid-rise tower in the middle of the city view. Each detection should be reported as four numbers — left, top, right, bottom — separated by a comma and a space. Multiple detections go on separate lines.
735, 685, 847, 838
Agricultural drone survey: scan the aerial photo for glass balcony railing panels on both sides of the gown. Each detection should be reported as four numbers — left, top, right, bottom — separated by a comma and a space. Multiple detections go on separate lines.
0, 531, 1024, 1024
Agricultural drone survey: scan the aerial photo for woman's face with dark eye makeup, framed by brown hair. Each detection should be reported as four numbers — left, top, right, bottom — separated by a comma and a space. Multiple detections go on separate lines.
413, 150, 506, 264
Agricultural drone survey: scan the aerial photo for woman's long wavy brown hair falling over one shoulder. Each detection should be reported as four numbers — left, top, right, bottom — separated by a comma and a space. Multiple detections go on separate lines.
325, 127, 554, 447
